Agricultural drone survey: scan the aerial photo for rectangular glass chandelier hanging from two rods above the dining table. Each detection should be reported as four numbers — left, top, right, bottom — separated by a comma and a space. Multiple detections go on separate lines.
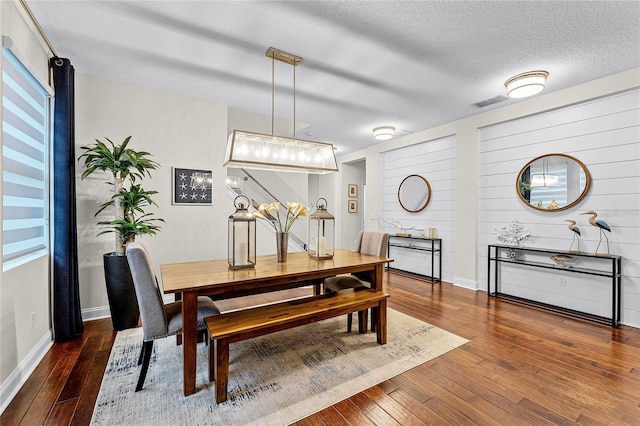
223, 47, 338, 174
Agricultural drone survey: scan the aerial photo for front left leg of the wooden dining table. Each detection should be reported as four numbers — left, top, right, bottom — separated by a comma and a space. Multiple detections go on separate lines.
182, 292, 198, 396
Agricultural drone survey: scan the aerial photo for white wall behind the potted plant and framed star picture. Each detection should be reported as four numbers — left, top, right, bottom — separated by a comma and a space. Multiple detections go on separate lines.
75, 74, 230, 318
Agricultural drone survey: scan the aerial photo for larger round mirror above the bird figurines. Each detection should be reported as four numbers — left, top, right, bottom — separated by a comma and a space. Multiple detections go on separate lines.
516, 154, 591, 211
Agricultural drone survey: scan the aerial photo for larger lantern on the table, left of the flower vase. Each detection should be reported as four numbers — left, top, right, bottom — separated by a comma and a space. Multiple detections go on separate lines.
228, 195, 256, 269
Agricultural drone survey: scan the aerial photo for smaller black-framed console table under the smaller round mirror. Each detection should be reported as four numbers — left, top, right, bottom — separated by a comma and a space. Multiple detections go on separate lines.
386, 235, 442, 283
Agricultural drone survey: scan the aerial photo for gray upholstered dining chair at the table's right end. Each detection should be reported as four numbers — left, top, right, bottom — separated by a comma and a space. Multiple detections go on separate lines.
324, 231, 389, 333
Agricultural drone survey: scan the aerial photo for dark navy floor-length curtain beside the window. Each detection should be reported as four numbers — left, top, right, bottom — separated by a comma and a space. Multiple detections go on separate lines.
50, 57, 84, 342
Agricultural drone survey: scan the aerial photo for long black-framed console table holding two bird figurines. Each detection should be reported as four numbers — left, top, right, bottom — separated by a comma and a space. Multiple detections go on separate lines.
487, 245, 622, 328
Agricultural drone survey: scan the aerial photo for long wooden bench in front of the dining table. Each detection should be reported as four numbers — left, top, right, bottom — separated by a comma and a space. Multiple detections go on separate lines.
205, 290, 389, 403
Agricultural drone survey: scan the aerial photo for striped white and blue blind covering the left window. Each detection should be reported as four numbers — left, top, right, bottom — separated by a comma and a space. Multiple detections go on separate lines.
2, 48, 49, 270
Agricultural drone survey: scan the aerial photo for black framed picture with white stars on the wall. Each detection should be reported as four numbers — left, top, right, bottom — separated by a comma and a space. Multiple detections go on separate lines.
173, 167, 213, 206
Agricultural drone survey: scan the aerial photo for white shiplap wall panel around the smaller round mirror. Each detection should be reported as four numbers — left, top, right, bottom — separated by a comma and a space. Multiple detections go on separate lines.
380, 136, 456, 282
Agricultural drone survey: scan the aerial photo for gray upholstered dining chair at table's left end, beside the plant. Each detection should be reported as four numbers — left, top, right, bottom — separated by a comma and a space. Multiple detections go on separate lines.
127, 242, 220, 392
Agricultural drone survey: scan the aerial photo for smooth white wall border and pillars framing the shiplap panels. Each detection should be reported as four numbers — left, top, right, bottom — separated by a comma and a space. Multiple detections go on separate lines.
338, 68, 640, 306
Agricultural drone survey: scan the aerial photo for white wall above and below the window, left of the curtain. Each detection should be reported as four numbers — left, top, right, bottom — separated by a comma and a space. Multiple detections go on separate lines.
0, 1, 51, 412
